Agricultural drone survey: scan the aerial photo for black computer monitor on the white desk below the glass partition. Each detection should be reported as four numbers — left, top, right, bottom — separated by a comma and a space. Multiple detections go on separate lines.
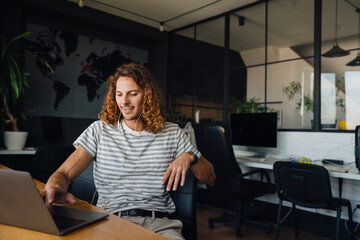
230, 113, 277, 148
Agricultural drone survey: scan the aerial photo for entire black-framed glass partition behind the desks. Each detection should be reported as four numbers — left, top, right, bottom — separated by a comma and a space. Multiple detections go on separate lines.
168, 0, 360, 131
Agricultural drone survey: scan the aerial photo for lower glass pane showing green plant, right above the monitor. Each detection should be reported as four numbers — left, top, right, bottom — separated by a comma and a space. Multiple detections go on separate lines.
267, 59, 314, 129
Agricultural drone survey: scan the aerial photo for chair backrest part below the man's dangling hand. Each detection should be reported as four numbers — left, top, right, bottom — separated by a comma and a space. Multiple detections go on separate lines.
170, 170, 197, 240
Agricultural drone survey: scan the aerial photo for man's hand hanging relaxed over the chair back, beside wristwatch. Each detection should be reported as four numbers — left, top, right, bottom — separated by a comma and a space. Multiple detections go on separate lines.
161, 152, 194, 191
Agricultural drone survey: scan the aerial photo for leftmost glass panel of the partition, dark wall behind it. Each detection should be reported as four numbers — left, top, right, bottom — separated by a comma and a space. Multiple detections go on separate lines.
168, 17, 224, 121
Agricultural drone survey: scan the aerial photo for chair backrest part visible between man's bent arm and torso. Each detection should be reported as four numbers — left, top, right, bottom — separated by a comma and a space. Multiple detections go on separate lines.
68, 161, 98, 205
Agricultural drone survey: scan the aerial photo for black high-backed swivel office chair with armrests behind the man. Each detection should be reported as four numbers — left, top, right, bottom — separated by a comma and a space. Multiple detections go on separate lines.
194, 124, 275, 237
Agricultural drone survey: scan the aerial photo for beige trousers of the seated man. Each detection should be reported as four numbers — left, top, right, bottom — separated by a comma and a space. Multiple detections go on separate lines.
122, 216, 184, 240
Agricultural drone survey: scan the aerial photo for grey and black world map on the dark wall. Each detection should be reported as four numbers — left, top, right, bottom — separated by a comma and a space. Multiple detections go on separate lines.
25, 23, 148, 118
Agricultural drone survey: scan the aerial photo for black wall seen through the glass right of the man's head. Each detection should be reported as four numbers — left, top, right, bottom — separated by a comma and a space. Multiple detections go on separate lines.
168, 33, 247, 102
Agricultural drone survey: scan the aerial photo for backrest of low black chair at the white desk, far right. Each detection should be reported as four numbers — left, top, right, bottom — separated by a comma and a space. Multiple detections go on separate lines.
273, 161, 332, 208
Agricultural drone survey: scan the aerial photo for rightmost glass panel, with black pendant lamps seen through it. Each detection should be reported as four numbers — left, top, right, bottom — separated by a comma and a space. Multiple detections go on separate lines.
321, 0, 360, 130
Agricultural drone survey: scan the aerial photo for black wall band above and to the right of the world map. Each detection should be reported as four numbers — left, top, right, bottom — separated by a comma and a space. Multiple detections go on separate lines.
0, 0, 167, 94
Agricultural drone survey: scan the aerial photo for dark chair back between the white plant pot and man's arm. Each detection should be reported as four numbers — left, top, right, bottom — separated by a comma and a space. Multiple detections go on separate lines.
31, 145, 75, 183
